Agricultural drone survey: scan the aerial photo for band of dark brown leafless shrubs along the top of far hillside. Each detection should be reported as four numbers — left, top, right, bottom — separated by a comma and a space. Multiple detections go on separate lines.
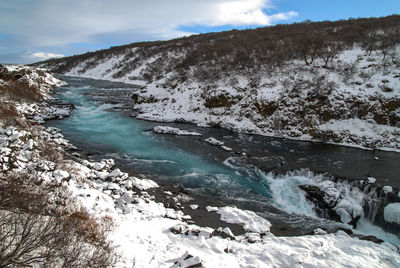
33, 15, 400, 82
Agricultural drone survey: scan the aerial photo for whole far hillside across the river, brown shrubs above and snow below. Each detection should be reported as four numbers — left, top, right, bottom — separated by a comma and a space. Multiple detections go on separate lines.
36, 16, 400, 150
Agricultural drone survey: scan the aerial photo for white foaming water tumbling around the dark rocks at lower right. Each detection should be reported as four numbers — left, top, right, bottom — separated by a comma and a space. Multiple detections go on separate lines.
224, 158, 400, 245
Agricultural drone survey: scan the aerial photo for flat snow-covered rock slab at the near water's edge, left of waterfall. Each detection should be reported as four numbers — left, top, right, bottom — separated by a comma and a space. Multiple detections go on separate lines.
217, 207, 271, 233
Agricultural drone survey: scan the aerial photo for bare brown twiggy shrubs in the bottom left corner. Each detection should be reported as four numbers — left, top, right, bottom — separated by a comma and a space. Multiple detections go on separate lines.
0, 175, 116, 267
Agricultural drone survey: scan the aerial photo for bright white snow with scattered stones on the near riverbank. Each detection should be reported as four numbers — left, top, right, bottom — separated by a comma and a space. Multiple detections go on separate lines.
0, 66, 400, 267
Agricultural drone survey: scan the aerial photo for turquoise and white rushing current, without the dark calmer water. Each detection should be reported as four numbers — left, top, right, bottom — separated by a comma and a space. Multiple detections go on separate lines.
49, 76, 400, 244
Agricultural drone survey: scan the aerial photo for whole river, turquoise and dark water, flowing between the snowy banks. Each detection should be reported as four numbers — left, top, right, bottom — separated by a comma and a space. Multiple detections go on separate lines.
47, 77, 400, 244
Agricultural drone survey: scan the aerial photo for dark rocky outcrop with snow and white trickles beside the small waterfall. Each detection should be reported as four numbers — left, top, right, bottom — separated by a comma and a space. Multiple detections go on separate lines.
299, 178, 400, 235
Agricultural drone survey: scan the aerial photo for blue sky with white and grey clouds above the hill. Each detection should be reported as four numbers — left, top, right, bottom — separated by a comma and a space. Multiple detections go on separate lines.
0, 0, 400, 64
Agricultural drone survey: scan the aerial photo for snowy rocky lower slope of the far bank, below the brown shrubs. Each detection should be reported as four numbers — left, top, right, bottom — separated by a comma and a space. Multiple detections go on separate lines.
40, 44, 400, 151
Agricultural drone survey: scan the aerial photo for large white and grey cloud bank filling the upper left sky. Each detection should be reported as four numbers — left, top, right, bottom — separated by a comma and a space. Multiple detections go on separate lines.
0, 0, 296, 63
